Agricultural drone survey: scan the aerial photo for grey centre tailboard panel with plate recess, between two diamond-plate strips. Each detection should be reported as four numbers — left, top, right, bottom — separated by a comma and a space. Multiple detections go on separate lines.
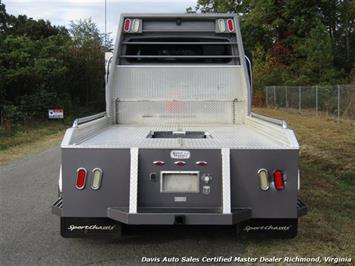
138, 148, 222, 210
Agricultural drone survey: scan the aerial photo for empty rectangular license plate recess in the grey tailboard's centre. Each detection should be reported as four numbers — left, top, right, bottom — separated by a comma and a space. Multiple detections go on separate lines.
160, 171, 200, 193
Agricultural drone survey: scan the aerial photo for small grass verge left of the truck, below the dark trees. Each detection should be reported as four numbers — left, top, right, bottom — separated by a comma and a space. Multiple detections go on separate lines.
0, 121, 68, 165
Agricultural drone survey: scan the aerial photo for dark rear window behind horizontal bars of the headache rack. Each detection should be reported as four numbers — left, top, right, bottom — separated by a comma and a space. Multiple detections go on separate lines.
120, 37, 238, 64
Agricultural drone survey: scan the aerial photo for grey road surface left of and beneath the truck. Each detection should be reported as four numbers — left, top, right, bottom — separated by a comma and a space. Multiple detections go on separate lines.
0, 146, 243, 266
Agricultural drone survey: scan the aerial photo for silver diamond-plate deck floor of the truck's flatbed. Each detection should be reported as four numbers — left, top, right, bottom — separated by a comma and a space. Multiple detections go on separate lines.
70, 124, 292, 149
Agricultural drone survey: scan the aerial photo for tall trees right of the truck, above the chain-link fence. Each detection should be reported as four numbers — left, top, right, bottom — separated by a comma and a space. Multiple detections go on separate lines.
187, 0, 355, 91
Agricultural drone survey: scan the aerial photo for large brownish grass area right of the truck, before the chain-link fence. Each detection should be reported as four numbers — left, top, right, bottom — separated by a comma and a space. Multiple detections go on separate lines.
246, 108, 355, 264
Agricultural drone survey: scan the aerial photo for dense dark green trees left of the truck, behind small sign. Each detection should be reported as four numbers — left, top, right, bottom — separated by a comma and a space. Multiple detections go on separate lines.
0, 4, 111, 124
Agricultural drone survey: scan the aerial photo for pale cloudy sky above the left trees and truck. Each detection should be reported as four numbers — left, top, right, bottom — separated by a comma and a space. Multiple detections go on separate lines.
0, 0, 196, 38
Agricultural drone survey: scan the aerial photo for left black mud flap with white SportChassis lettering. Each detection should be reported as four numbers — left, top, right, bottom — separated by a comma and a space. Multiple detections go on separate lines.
60, 217, 122, 239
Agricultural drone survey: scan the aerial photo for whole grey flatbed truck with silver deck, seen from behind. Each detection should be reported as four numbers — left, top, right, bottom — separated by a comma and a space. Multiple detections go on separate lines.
52, 14, 307, 238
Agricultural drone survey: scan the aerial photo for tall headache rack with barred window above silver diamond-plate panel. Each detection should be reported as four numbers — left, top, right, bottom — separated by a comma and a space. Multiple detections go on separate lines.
110, 15, 245, 125
